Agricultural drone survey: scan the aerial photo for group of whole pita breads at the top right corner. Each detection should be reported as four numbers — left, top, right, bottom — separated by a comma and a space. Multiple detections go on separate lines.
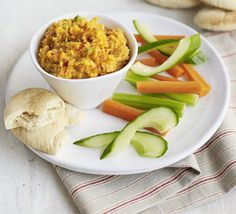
146, 0, 236, 31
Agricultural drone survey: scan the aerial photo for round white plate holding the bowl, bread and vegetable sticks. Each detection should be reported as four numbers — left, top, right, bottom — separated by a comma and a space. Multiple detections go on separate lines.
6, 13, 229, 174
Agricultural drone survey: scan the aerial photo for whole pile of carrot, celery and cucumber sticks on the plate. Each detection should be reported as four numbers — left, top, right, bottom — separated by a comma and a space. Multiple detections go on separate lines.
74, 20, 211, 159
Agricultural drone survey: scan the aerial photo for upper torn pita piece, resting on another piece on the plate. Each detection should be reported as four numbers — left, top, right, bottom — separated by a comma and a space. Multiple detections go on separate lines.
4, 88, 65, 130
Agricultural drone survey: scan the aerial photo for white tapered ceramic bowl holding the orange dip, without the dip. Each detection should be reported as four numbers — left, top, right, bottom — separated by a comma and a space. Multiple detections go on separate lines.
30, 12, 138, 109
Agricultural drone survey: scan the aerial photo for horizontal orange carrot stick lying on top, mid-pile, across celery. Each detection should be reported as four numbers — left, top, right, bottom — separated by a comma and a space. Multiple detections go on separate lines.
136, 81, 201, 94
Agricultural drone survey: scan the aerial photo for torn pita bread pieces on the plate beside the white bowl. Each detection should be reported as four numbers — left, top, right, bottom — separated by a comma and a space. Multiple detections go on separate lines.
4, 88, 81, 154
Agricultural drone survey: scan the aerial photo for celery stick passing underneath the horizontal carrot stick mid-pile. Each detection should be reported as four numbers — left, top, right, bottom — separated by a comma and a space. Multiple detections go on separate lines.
125, 71, 199, 106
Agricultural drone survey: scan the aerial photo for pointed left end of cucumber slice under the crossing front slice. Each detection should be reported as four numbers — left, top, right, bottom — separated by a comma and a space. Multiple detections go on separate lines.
74, 131, 120, 148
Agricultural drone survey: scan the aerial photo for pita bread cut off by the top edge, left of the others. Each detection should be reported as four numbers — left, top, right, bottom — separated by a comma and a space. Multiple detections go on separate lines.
146, 0, 200, 9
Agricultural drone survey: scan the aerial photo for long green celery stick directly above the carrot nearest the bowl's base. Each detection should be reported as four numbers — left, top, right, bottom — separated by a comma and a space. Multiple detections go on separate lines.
112, 93, 186, 117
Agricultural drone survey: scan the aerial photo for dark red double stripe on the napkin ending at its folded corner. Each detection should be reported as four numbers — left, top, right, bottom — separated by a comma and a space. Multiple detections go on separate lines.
103, 168, 189, 214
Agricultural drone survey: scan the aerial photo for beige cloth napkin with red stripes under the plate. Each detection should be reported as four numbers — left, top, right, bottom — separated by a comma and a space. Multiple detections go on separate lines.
55, 32, 236, 214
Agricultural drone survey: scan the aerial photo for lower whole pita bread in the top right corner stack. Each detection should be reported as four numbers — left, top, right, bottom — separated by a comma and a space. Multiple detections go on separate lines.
194, 7, 236, 31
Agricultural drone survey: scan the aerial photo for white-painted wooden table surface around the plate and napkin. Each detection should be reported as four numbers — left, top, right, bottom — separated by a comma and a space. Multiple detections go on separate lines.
0, 0, 236, 214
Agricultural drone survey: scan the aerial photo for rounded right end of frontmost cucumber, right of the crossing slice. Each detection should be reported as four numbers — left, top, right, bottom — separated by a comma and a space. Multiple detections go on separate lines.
131, 132, 168, 158
